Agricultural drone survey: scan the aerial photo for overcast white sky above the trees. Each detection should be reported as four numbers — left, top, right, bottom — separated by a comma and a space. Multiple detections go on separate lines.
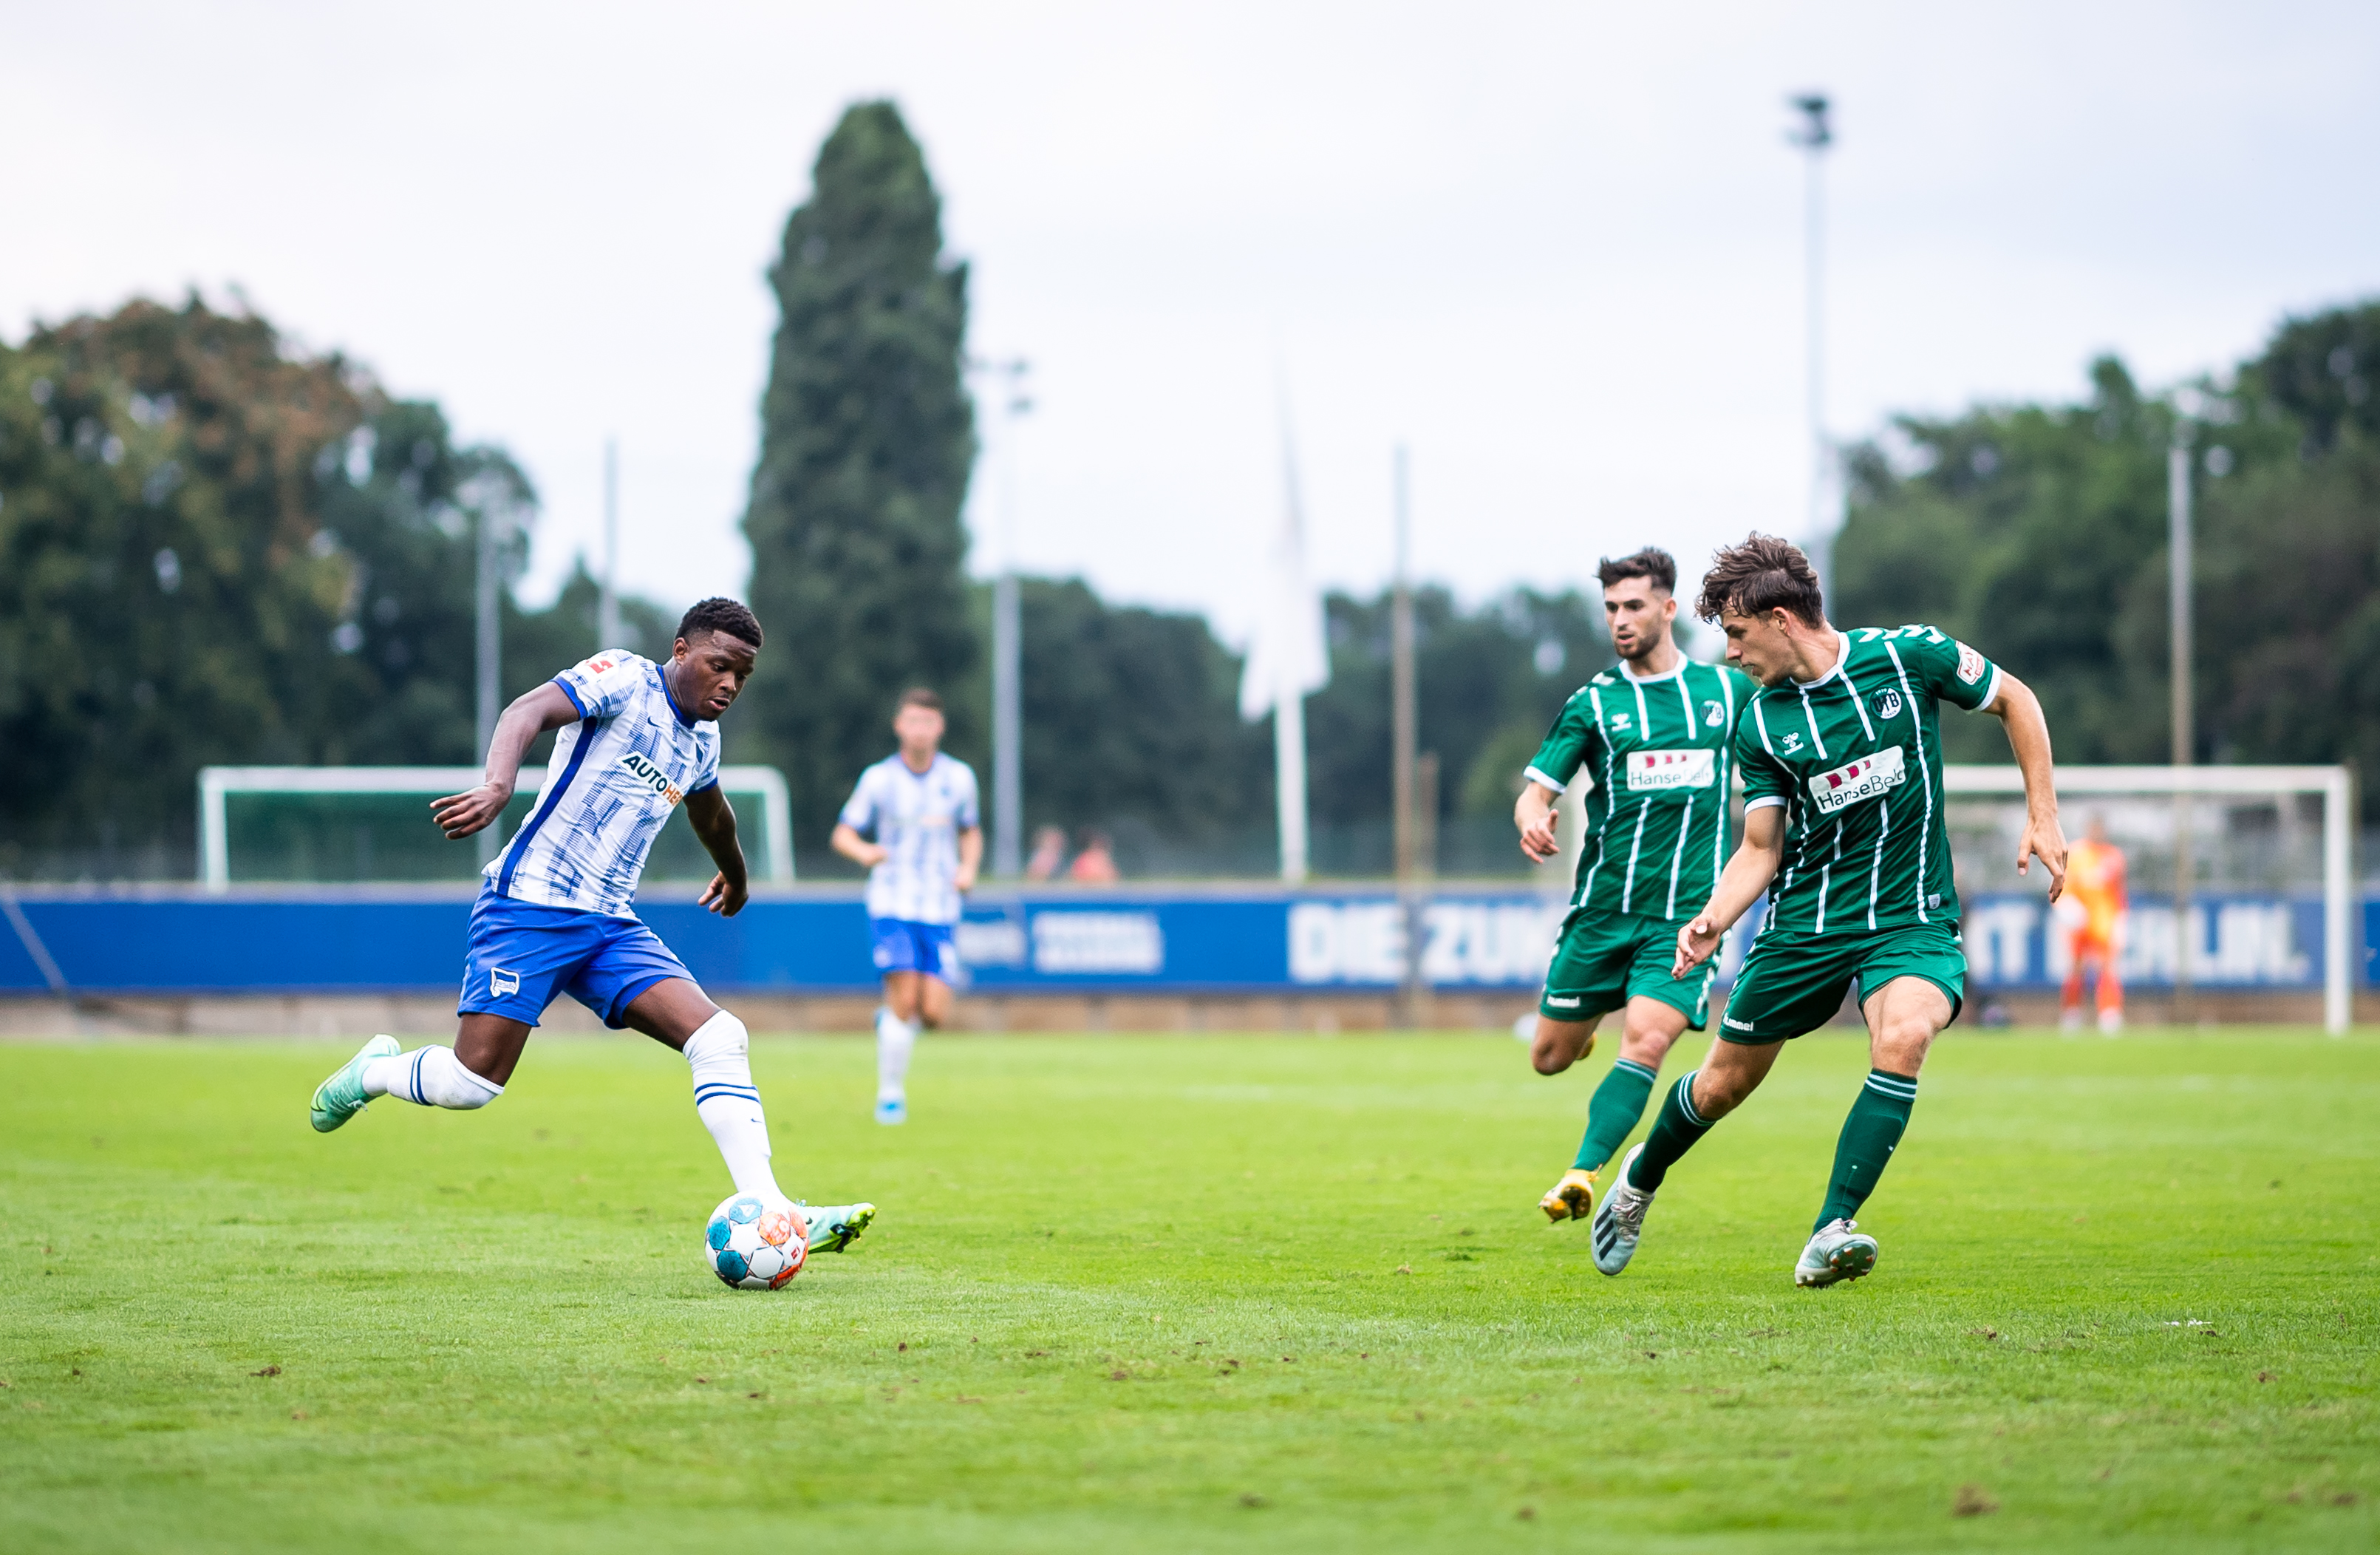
0, 0, 2380, 639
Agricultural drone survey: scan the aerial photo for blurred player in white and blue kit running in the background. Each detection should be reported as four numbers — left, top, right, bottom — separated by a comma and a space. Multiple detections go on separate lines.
833, 688, 983, 1124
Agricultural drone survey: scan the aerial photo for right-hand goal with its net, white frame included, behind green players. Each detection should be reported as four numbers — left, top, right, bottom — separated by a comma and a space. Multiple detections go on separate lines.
1942, 764, 2363, 1031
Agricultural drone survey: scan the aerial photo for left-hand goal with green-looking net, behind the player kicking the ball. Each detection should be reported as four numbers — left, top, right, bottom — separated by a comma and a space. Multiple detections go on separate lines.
197, 767, 793, 891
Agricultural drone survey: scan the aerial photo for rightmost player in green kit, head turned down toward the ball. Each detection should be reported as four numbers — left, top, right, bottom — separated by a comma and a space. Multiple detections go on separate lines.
1590, 534, 2066, 1286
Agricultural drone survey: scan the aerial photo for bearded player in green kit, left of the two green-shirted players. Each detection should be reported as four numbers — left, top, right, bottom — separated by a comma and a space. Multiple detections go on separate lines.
1514, 548, 1754, 1224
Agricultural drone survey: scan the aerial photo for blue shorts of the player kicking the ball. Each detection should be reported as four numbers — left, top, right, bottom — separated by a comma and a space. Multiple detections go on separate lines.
454, 888, 695, 1029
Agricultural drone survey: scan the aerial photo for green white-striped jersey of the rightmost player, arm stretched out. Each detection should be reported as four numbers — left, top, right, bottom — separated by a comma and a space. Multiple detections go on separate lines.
1735, 626, 1999, 933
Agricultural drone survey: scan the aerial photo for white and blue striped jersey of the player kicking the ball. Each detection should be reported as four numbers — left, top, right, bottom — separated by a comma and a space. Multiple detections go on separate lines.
488, 647, 719, 916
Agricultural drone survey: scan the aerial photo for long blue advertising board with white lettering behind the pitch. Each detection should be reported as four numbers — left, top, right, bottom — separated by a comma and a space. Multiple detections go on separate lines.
0, 888, 2380, 996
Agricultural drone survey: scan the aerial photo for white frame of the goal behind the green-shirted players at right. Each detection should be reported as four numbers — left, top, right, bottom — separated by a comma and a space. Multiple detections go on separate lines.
1942, 764, 2359, 1036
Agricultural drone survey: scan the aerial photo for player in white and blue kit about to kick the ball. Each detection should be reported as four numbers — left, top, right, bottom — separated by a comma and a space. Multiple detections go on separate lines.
314, 600, 876, 1253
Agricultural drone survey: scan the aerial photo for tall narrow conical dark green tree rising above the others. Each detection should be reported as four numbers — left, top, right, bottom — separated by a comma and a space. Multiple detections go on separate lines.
745, 103, 978, 848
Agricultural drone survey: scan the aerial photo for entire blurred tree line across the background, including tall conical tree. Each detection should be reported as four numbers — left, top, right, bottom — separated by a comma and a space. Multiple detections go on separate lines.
0, 124, 2380, 879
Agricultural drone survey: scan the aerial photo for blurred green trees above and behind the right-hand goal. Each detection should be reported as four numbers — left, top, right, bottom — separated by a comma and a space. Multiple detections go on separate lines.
1830, 302, 2380, 800
